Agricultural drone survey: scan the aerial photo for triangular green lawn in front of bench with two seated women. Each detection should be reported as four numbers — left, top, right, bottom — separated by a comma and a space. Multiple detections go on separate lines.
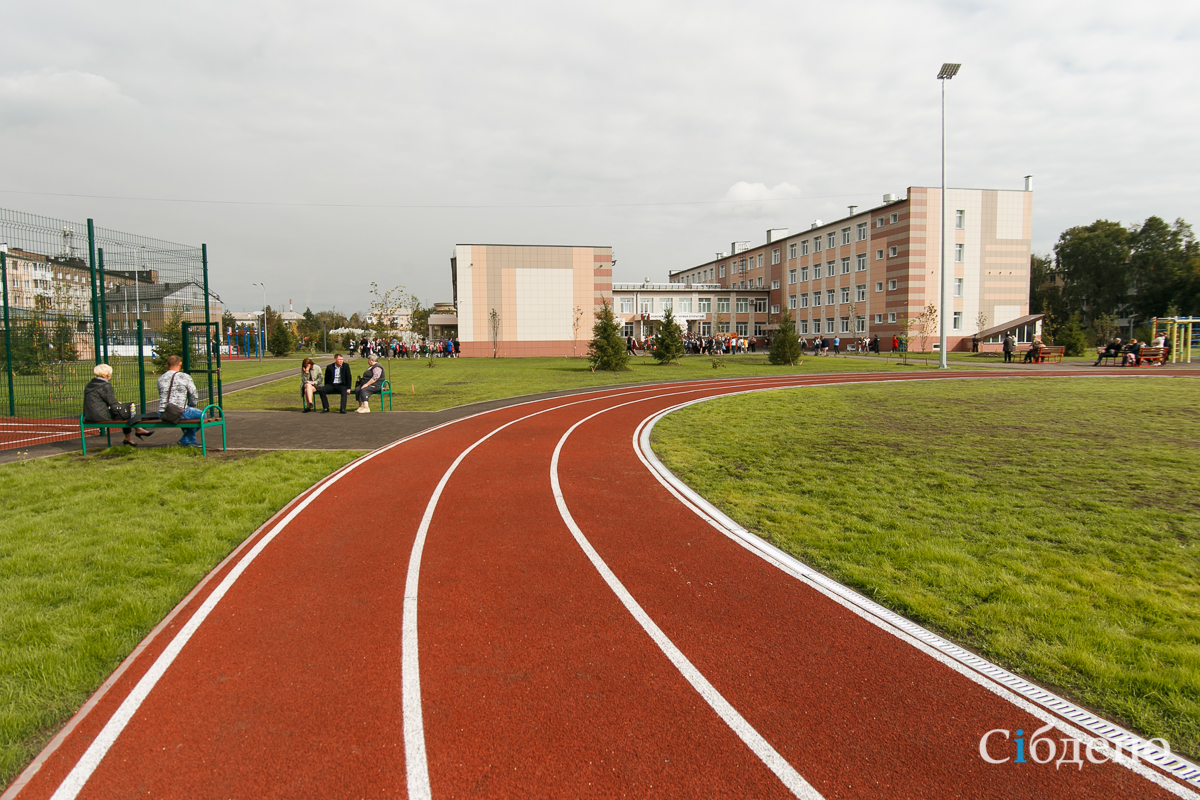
0, 447, 359, 787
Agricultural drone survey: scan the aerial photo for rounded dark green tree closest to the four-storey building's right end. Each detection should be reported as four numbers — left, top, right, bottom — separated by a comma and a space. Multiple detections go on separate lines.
1054, 219, 1130, 319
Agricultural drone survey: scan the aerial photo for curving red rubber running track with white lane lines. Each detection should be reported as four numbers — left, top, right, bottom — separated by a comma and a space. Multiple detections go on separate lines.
9, 372, 1200, 800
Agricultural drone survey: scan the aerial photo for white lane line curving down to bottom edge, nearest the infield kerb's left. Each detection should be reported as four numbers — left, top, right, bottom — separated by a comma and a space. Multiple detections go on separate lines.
550, 395, 821, 800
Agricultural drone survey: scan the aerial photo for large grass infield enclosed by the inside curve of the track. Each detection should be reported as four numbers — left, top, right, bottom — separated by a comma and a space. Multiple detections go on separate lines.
654, 378, 1200, 758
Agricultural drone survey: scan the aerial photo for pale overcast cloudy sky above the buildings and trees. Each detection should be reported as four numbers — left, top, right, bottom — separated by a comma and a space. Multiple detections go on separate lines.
0, 0, 1200, 313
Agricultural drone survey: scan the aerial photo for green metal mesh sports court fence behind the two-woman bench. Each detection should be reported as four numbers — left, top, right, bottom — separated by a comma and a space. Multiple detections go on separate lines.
0, 209, 221, 449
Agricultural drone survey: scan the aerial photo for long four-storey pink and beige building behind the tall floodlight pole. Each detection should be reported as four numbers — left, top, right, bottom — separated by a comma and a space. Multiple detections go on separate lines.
672, 179, 1040, 350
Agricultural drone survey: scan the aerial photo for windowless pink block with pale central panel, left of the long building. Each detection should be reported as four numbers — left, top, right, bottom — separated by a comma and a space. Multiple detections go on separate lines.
451, 245, 612, 357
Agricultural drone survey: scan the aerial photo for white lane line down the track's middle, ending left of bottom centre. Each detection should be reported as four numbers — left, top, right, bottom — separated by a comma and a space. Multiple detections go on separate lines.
401, 379, 806, 800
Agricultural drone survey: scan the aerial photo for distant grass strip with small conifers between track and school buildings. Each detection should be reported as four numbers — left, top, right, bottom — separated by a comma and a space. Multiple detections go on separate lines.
226, 354, 937, 411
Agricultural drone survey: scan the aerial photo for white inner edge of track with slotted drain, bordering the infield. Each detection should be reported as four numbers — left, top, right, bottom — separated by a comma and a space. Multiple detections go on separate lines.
634, 375, 1200, 800
